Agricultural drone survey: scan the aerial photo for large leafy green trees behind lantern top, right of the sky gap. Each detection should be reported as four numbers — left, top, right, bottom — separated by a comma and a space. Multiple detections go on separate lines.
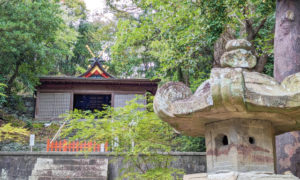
107, 0, 275, 89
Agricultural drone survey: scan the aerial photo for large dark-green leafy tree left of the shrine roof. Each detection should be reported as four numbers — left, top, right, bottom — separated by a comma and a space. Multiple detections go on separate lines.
0, 0, 74, 96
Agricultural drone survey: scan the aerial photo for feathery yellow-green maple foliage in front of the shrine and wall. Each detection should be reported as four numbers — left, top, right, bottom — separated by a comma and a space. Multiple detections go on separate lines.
63, 97, 181, 180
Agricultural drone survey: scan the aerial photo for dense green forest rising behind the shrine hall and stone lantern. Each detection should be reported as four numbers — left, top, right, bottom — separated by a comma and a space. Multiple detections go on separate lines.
0, 0, 276, 151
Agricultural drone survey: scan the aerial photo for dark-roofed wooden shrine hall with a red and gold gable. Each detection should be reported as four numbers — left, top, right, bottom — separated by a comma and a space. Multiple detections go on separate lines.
35, 53, 160, 121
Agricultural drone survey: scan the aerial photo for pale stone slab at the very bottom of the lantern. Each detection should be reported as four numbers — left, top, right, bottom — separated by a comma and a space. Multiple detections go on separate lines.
183, 171, 299, 180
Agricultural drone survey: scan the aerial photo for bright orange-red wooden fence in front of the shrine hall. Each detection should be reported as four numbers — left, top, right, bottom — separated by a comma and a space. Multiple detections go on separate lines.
47, 139, 108, 152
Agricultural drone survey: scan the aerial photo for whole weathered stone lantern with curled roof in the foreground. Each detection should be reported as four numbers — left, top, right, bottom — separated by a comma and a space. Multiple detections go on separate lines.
154, 39, 300, 180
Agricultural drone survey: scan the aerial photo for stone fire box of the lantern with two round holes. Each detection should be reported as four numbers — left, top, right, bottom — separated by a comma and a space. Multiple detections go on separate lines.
205, 119, 275, 173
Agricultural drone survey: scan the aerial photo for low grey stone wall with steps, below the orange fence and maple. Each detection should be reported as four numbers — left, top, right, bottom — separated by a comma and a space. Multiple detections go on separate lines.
0, 152, 206, 180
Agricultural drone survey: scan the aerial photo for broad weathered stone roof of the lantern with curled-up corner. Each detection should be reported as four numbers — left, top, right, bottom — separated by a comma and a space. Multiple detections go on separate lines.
154, 68, 300, 136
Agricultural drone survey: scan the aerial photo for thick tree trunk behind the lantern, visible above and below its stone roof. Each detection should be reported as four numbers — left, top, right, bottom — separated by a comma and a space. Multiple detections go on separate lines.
274, 0, 300, 177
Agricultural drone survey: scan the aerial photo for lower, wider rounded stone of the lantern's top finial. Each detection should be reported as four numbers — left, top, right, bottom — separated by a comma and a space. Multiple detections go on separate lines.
220, 49, 256, 69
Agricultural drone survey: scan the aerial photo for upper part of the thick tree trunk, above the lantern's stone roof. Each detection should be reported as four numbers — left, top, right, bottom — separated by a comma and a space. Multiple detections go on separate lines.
274, 0, 300, 82
